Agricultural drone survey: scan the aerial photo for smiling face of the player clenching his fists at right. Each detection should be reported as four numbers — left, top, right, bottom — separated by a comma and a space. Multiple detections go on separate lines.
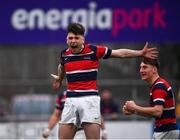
140, 62, 154, 82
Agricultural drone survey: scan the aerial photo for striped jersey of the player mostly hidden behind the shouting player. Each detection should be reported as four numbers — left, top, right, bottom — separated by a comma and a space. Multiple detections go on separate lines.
56, 91, 66, 111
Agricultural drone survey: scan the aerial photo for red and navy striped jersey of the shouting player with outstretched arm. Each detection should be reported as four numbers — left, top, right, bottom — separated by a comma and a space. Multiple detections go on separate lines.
61, 44, 111, 97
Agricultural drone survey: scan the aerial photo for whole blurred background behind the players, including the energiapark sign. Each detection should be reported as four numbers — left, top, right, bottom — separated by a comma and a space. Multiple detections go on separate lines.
0, 0, 180, 139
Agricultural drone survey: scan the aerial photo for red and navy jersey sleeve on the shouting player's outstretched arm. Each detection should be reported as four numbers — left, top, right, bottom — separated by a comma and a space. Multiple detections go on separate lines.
96, 46, 112, 59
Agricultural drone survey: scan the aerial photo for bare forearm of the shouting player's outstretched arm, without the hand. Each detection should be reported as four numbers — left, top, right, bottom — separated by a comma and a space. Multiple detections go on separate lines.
111, 49, 143, 58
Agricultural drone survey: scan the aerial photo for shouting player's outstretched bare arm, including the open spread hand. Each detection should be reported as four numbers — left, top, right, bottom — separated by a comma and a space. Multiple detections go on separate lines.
111, 42, 158, 59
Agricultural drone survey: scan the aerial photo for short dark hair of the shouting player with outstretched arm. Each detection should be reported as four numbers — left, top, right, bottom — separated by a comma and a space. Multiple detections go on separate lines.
67, 23, 85, 36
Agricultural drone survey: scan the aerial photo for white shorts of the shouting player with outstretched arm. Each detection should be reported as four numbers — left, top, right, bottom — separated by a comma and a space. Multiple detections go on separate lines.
60, 95, 101, 126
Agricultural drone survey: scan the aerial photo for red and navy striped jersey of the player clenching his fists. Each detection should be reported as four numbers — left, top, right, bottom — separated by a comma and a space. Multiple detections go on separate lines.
150, 77, 177, 132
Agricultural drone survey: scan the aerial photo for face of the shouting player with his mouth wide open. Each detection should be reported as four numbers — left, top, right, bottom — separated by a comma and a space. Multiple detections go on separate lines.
67, 33, 84, 49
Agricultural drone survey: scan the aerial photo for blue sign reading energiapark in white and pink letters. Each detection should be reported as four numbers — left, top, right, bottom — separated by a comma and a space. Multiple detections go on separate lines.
0, 0, 180, 44
